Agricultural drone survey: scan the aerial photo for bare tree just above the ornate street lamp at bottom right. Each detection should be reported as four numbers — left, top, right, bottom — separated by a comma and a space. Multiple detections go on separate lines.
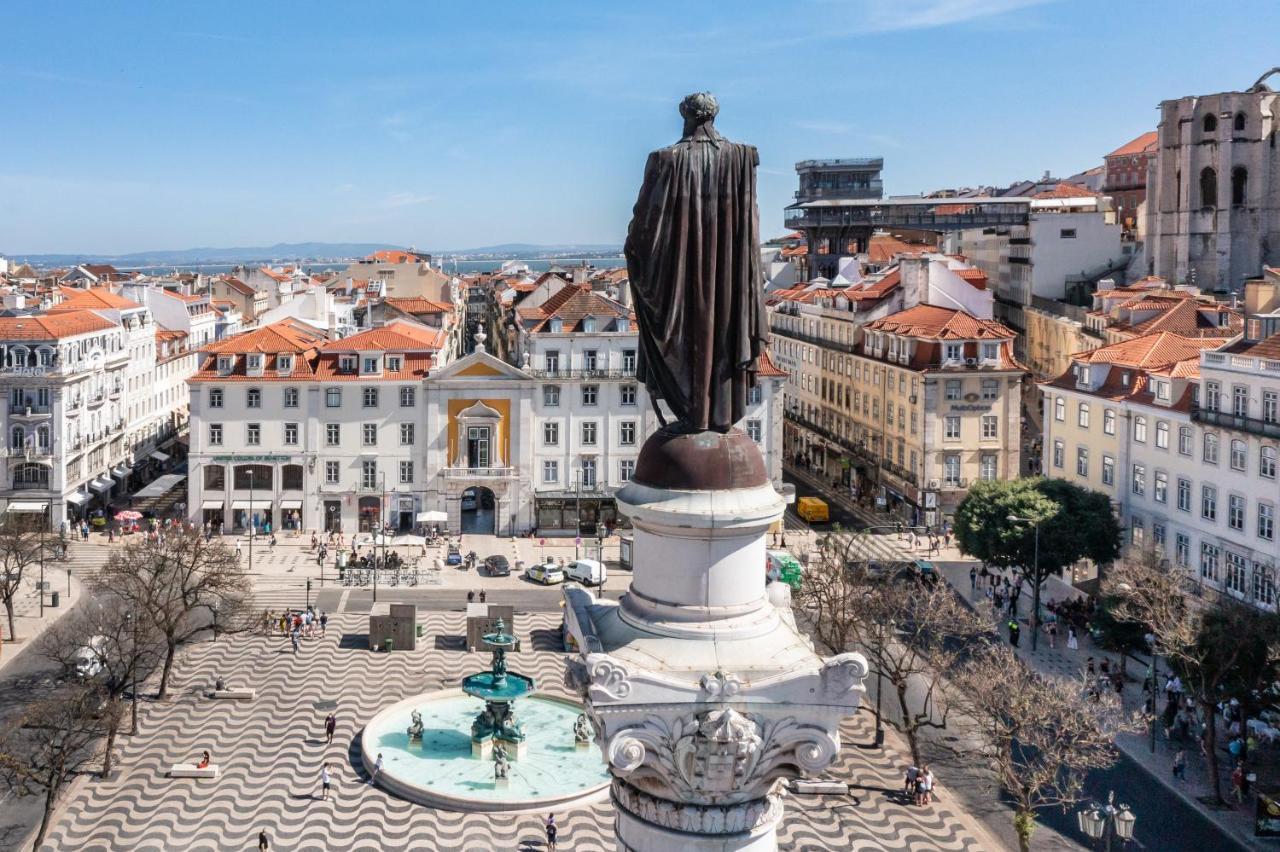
956, 645, 1142, 852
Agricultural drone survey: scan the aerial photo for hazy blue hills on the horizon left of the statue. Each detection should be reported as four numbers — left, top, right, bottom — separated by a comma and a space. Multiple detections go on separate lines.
10, 243, 622, 267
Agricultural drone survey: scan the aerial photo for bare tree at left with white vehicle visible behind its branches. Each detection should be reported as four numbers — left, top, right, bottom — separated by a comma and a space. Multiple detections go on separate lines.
40, 594, 165, 778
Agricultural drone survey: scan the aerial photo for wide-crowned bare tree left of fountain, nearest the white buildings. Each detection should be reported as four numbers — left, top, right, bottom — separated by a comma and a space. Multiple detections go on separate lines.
96, 530, 251, 698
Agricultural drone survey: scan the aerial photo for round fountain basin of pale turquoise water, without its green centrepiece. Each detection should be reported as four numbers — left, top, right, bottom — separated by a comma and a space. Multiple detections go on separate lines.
360, 690, 609, 812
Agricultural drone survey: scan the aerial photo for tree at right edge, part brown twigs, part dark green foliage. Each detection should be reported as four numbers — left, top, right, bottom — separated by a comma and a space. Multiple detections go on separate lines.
1103, 550, 1280, 802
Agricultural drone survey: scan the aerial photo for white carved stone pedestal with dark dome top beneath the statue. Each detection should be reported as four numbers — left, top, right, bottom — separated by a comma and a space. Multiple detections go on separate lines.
564, 430, 867, 852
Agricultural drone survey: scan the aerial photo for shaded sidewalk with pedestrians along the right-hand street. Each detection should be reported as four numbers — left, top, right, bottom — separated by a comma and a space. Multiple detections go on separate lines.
941, 560, 1267, 846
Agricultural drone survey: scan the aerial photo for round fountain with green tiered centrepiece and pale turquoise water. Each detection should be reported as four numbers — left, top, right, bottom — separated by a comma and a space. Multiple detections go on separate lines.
361, 619, 609, 811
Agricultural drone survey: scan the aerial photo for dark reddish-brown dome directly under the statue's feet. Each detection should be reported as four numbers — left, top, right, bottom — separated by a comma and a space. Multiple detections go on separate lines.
631, 423, 769, 491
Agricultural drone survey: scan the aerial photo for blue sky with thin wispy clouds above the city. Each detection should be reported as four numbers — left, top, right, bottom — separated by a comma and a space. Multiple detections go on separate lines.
0, 0, 1280, 253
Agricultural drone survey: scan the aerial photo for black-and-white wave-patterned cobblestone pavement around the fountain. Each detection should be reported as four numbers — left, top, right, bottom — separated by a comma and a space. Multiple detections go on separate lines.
37, 613, 982, 852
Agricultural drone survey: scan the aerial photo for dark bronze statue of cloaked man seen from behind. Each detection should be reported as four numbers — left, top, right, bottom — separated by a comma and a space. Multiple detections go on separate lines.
626, 92, 768, 432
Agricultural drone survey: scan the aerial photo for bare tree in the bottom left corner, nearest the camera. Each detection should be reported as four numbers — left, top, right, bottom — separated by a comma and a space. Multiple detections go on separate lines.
0, 683, 114, 849
